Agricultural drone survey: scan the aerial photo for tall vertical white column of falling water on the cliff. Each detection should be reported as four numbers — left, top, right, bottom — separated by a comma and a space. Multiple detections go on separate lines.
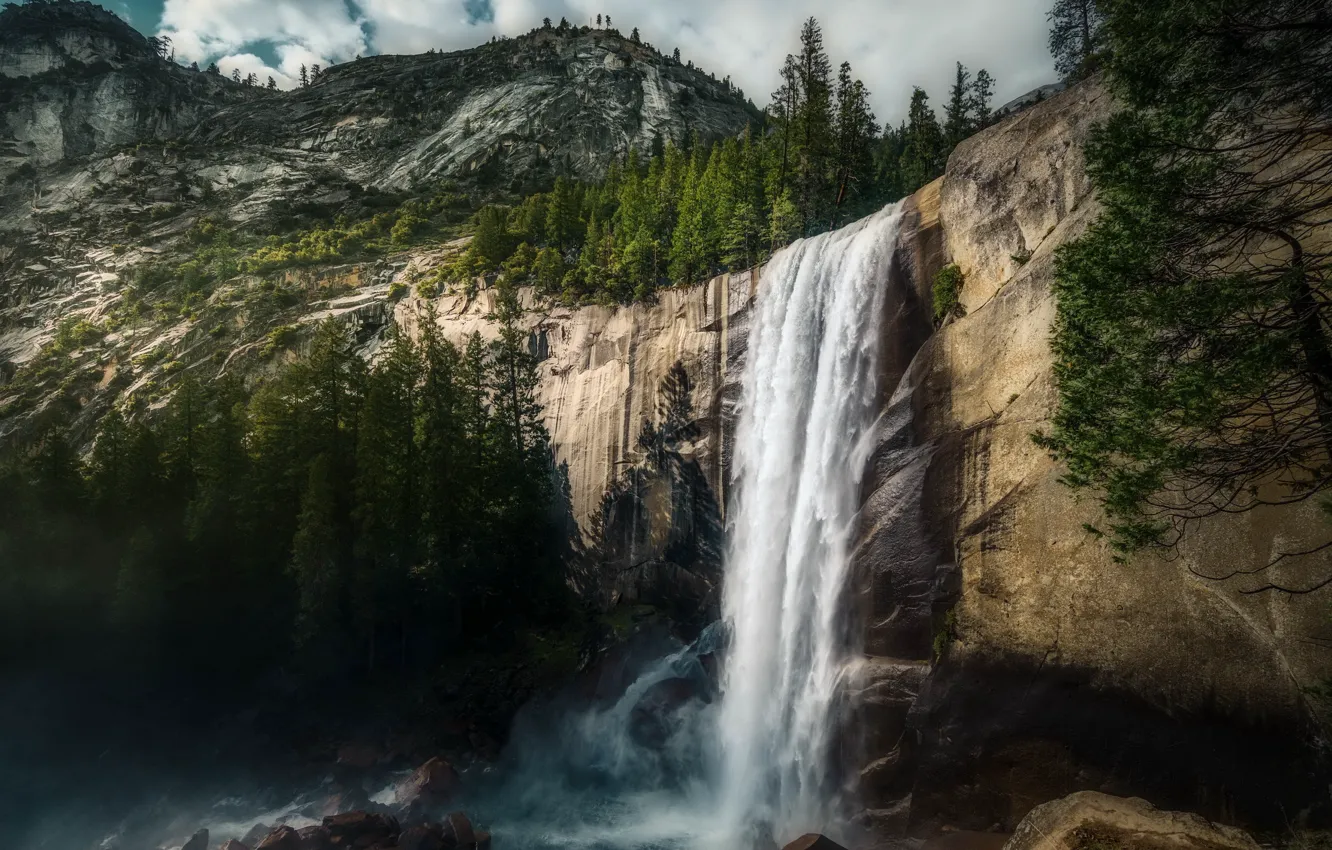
718, 205, 902, 842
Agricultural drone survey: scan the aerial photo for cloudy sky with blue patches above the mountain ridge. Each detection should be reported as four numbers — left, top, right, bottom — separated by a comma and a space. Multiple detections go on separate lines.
109, 0, 1055, 123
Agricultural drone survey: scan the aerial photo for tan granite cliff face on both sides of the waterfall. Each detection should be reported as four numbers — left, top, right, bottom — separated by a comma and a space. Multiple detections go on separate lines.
398, 76, 1332, 835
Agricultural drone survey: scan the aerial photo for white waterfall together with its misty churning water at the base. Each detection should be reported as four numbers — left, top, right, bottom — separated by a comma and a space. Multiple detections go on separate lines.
72, 207, 900, 850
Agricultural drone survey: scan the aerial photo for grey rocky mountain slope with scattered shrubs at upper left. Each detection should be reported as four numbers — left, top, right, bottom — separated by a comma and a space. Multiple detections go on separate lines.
0, 0, 759, 450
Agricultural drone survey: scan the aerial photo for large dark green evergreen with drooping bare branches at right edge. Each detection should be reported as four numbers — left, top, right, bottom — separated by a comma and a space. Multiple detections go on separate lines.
1040, 0, 1332, 590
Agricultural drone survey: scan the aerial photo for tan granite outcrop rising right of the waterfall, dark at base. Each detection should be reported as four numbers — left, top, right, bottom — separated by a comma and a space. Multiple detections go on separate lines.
856, 83, 1332, 831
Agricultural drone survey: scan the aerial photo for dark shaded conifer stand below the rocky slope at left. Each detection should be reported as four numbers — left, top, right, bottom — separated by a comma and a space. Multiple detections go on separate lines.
0, 294, 571, 679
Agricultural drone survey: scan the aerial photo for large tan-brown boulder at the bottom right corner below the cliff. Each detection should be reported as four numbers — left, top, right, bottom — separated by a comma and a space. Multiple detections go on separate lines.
1004, 791, 1257, 850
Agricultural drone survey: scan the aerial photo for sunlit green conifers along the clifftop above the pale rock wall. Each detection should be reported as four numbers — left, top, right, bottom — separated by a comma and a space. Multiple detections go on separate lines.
449, 19, 994, 301
